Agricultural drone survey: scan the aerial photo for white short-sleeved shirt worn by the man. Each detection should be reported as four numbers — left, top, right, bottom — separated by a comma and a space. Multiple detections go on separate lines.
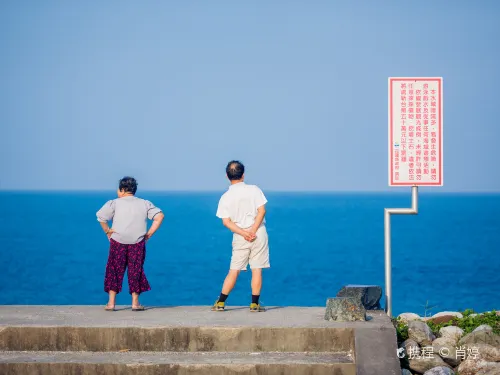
216, 182, 267, 229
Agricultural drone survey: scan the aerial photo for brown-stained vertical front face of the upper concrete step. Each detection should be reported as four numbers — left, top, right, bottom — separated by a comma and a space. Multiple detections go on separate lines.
0, 327, 354, 352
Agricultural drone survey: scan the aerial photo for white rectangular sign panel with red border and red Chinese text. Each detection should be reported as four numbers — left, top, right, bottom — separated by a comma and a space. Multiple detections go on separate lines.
389, 77, 443, 186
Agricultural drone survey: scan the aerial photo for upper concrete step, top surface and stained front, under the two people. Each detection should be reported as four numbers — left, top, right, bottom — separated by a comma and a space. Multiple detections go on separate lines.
0, 306, 355, 352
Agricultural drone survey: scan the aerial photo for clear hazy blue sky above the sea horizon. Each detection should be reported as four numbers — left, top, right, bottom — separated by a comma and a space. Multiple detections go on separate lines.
0, 0, 500, 191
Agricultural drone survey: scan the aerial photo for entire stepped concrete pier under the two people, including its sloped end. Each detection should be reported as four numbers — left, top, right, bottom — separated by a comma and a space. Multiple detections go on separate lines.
0, 306, 400, 375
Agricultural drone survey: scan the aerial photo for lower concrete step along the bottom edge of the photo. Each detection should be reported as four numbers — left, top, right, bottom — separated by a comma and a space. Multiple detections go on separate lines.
0, 352, 356, 375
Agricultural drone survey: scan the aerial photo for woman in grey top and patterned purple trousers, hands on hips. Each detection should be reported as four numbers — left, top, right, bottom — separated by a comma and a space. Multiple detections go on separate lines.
97, 177, 164, 311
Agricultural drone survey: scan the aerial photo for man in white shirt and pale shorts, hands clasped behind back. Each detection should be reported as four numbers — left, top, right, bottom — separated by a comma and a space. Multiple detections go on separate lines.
212, 160, 270, 312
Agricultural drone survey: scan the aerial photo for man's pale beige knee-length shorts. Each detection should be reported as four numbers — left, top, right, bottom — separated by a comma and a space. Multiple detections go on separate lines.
230, 226, 271, 271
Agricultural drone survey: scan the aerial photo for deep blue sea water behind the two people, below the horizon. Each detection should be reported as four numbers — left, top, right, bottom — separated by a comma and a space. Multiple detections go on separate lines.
0, 192, 500, 315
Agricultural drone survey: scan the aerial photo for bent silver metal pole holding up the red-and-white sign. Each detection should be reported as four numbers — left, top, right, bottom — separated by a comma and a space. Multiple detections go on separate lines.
384, 186, 418, 317
